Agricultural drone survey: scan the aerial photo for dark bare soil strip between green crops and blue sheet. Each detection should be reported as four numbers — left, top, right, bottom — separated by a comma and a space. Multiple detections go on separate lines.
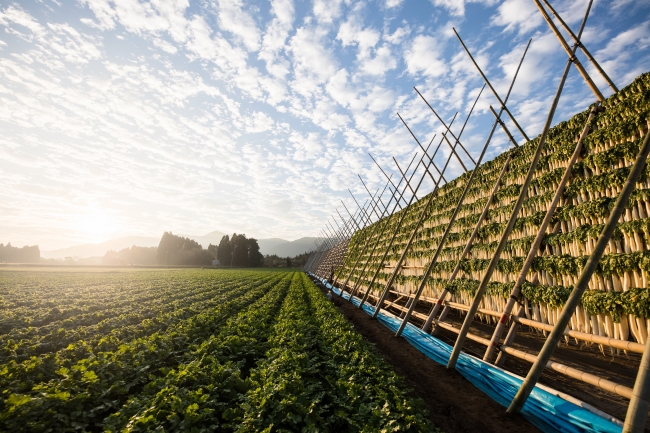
316, 282, 539, 433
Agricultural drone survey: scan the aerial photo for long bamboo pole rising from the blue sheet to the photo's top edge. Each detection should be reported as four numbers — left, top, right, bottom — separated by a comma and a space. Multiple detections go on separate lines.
447, 11, 586, 368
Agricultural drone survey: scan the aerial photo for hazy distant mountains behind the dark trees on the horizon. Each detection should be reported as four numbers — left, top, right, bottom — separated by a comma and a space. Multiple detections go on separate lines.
41, 230, 316, 259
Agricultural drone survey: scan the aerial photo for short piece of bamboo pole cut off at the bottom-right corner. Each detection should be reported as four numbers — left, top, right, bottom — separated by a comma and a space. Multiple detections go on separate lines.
623, 339, 650, 433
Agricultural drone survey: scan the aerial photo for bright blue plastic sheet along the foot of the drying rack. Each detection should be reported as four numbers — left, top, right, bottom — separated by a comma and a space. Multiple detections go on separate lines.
310, 274, 622, 433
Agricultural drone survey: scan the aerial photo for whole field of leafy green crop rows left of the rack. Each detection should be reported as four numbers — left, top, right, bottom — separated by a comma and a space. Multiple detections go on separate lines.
0, 269, 435, 432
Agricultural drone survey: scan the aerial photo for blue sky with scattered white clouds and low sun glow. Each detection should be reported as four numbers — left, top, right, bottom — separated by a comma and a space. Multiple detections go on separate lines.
0, 0, 650, 250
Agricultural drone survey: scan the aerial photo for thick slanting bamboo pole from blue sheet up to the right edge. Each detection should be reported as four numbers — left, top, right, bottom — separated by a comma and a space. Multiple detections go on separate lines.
508, 123, 650, 412
